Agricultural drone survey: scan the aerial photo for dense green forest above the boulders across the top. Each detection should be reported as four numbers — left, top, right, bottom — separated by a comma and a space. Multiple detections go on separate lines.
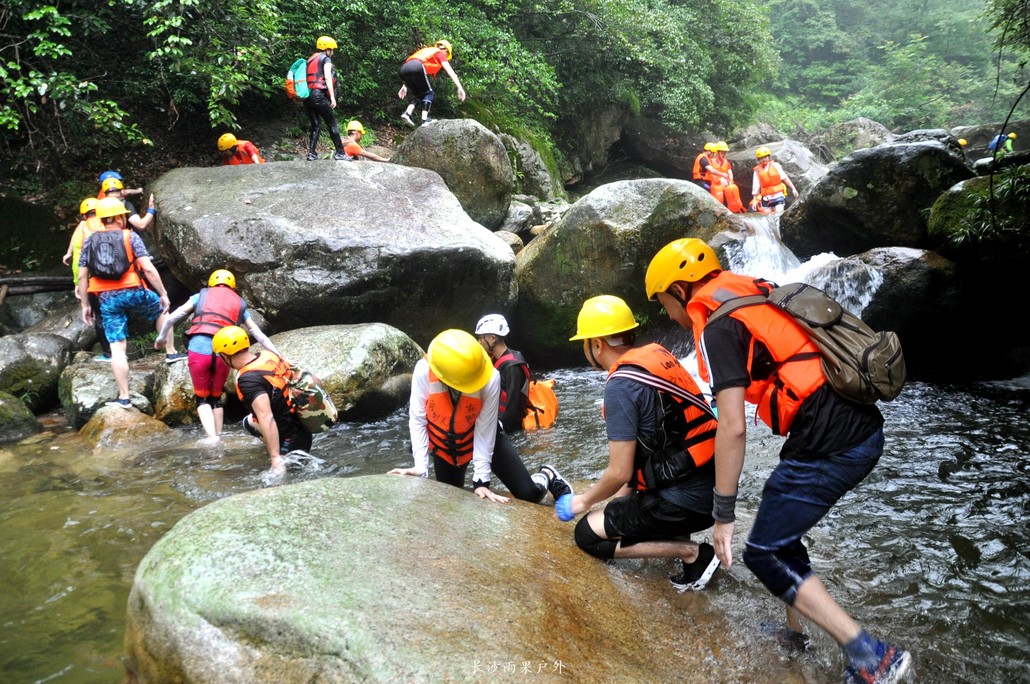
0, 0, 1030, 200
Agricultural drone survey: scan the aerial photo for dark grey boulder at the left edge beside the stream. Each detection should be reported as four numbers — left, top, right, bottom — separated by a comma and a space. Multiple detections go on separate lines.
0, 333, 72, 411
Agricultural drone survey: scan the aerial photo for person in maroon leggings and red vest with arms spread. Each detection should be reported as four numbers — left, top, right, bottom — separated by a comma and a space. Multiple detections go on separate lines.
153, 269, 279, 444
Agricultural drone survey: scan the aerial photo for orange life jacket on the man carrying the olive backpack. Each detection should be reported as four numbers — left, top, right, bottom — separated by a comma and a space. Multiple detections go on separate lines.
687, 271, 826, 436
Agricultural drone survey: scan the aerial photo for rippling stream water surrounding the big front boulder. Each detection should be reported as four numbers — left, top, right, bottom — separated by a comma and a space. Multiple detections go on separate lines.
0, 221, 1030, 683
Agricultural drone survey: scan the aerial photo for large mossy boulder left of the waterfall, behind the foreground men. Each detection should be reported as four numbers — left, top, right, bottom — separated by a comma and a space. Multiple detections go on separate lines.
512, 179, 744, 367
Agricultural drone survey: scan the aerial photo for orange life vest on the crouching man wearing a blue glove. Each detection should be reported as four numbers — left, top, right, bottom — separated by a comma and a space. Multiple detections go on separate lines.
608, 344, 717, 490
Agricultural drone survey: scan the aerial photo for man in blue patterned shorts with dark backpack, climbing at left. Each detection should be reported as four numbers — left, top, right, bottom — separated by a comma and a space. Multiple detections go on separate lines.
77, 197, 185, 409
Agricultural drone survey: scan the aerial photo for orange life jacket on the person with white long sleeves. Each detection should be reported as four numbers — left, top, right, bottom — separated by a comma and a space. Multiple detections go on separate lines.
425, 369, 483, 468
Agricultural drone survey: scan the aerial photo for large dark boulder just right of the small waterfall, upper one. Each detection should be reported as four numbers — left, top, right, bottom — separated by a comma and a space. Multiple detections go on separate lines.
781, 140, 972, 259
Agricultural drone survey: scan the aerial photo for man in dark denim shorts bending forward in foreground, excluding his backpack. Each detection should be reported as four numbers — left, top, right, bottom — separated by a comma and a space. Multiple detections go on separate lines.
645, 238, 912, 684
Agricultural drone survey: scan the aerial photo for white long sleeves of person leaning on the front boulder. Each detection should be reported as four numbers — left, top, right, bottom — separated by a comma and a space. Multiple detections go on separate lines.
408, 358, 501, 483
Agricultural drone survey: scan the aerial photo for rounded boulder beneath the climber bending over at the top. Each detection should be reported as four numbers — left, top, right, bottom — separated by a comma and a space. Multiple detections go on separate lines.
392, 118, 515, 230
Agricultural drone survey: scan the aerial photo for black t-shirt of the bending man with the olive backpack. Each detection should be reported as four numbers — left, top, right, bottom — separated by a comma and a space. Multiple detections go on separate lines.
701, 316, 884, 460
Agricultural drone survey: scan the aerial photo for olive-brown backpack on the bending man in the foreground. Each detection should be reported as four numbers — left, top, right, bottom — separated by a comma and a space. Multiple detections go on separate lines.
709, 282, 907, 404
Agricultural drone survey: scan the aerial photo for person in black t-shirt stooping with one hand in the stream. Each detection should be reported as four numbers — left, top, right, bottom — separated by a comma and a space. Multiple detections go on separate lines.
211, 326, 313, 476
